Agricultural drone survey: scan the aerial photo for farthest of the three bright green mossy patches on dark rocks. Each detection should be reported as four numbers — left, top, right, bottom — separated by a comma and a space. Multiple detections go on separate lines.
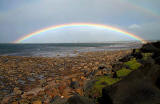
124, 58, 141, 70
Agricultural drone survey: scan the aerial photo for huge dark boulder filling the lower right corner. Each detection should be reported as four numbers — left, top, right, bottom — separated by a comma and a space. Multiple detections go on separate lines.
100, 59, 160, 104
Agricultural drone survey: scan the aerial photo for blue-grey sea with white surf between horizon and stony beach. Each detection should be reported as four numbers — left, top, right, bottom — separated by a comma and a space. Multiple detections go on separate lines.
0, 42, 141, 57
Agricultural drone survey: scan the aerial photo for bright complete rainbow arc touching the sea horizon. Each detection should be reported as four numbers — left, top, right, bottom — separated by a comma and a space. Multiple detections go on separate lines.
13, 23, 147, 43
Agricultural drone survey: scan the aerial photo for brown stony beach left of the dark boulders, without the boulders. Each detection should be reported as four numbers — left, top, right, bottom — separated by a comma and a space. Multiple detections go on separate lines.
0, 50, 132, 104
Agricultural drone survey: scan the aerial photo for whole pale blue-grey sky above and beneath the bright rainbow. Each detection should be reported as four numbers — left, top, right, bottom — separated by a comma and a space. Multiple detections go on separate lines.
0, 0, 160, 43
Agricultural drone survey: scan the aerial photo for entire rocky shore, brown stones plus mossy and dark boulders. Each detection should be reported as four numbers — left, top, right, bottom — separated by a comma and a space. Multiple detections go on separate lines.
0, 42, 160, 104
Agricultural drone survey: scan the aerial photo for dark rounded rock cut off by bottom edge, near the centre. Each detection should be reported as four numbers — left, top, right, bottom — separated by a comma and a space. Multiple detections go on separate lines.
66, 96, 95, 104
